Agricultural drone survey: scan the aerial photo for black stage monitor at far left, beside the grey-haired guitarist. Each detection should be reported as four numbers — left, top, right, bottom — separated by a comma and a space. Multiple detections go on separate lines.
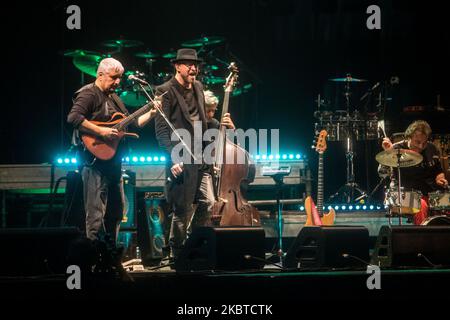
0, 227, 81, 276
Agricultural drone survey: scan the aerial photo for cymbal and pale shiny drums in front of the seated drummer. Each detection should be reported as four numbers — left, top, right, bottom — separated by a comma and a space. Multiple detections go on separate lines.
375, 148, 450, 225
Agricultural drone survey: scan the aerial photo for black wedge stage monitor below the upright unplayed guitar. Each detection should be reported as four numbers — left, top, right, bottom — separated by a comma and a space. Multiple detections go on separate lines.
283, 226, 369, 269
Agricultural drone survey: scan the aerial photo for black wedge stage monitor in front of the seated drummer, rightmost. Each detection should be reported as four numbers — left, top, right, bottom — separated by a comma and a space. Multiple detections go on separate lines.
372, 226, 450, 268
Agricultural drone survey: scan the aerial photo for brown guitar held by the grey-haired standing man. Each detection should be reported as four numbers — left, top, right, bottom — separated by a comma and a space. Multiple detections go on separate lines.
81, 102, 153, 160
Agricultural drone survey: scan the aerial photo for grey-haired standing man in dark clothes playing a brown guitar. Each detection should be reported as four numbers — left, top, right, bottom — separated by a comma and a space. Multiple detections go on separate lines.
67, 58, 156, 243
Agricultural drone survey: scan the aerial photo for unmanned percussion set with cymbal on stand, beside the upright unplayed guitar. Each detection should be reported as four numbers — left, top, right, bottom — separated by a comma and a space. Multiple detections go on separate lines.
314, 74, 380, 203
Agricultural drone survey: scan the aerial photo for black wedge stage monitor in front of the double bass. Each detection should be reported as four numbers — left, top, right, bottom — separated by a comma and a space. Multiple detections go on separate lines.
175, 227, 265, 271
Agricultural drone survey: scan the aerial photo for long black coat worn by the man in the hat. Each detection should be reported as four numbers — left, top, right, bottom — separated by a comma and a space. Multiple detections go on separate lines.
155, 80, 207, 212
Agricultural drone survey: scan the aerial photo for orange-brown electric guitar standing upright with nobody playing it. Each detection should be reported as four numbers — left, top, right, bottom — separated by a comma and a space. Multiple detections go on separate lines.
305, 130, 336, 226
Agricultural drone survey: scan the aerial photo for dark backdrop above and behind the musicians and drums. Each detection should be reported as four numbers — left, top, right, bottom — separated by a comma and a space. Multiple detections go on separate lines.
0, 0, 450, 200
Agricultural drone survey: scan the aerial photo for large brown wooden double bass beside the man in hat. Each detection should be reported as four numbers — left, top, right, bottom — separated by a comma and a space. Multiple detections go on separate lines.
212, 62, 261, 226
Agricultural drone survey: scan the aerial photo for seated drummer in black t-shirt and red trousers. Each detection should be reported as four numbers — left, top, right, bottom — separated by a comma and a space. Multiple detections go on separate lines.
379, 120, 448, 225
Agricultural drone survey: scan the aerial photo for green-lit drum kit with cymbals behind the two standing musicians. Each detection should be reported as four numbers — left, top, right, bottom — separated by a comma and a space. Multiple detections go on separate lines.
63, 36, 252, 108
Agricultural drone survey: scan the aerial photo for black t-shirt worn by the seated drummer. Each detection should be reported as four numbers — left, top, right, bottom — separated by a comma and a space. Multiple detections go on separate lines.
393, 141, 443, 195
